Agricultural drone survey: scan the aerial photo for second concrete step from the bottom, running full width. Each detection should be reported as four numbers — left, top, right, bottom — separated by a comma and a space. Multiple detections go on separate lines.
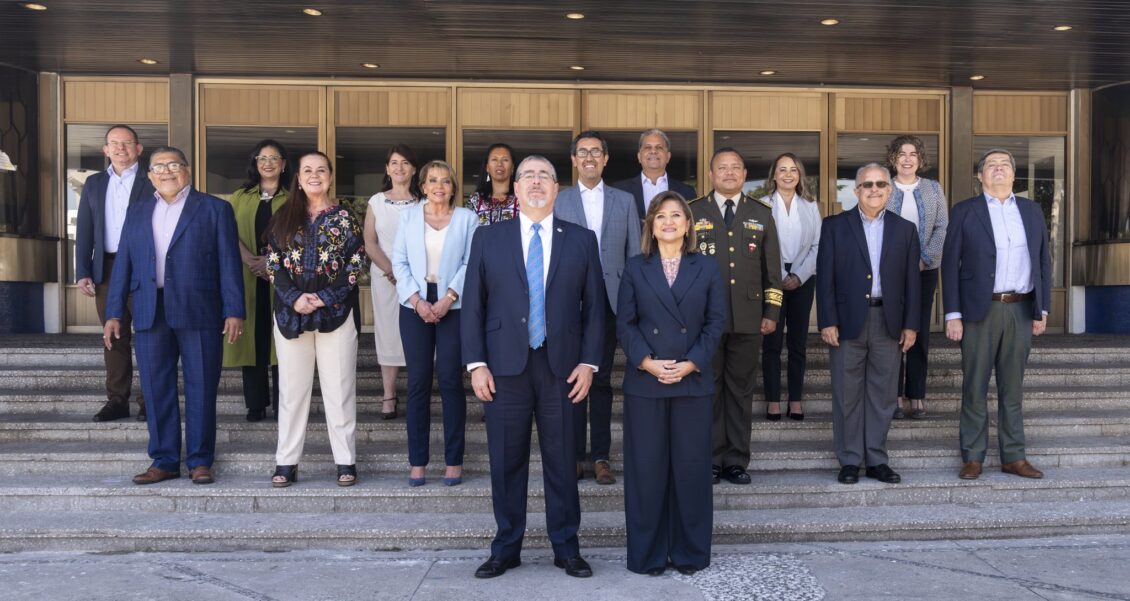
0, 468, 1130, 514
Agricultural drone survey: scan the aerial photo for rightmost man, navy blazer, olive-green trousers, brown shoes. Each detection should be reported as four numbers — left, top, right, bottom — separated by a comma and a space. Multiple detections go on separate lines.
941, 148, 1052, 480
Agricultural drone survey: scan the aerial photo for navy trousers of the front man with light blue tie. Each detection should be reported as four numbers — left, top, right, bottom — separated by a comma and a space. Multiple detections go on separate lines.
484, 345, 581, 561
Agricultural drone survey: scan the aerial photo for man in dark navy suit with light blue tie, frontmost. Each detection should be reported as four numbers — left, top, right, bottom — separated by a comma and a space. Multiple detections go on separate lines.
461, 155, 607, 578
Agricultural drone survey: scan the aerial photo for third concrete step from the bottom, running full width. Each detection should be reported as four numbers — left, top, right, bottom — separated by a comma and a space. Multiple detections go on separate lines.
0, 436, 1130, 478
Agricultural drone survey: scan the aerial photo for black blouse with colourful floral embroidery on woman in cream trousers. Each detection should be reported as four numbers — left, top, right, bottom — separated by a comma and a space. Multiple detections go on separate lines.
267, 207, 365, 338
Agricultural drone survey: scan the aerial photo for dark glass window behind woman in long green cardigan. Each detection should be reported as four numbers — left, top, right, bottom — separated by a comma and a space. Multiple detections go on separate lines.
203, 125, 318, 199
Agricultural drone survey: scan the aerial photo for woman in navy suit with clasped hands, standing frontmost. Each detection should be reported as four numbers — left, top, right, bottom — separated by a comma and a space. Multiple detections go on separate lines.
616, 191, 727, 576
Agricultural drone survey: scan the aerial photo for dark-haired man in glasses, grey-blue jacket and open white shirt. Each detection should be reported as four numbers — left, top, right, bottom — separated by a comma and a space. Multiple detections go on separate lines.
554, 131, 640, 485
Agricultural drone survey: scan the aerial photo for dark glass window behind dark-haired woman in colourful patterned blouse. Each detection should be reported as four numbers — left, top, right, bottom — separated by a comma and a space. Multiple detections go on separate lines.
460, 130, 573, 199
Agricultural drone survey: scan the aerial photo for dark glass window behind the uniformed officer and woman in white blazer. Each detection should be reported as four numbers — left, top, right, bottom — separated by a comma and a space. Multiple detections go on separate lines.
706, 131, 820, 201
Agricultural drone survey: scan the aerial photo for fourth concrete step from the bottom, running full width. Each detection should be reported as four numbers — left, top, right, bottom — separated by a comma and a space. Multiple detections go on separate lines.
0, 407, 1130, 446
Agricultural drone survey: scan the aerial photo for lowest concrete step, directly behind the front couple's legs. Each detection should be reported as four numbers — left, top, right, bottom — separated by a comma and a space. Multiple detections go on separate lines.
0, 494, 1130, 552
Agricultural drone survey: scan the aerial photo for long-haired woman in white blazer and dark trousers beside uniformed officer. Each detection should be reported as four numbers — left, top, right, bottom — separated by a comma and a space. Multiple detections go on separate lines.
762, 153, 820, 421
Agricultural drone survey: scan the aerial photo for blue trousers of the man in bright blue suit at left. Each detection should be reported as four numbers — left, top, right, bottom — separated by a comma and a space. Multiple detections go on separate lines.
134, 291, 224, 471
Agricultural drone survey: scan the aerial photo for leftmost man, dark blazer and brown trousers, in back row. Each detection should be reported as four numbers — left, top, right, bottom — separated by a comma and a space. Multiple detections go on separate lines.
75, 125, 154, 421
